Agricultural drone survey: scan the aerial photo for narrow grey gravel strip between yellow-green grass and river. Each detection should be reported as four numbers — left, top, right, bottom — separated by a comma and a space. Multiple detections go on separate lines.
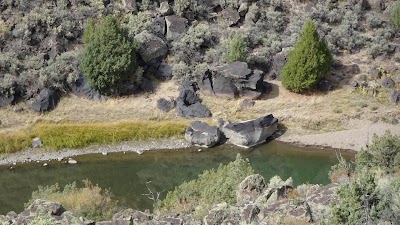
0, 139, 191, 165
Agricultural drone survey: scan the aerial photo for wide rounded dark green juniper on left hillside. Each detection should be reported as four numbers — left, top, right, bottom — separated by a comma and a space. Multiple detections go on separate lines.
81, 16, 137, 95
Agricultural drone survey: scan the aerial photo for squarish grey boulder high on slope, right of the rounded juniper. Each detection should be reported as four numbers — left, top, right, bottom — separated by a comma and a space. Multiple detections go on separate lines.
165, 15, 188, 41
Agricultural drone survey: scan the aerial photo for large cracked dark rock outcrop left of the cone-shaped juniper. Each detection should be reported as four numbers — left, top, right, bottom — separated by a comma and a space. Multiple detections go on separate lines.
199, 62, 266, 99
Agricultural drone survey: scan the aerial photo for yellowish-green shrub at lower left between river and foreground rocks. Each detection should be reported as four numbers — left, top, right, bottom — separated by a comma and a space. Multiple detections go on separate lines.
25, 180, 118, 221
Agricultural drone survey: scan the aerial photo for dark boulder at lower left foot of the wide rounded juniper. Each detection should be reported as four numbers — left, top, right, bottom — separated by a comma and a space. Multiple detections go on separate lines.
69, 75, 107, 101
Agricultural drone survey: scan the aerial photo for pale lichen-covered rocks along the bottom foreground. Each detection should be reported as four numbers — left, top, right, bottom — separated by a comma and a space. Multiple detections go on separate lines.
0, 174, 337, 225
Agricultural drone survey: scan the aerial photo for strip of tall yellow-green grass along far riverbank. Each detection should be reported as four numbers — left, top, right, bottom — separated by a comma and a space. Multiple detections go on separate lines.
0, 120, 189, 154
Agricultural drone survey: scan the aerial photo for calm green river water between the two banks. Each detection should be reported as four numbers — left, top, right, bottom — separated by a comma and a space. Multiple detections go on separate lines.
0, 141, 354, 215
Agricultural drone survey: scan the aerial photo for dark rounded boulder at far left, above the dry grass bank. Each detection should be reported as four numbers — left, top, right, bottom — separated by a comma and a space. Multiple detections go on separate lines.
32, 88, 60, 112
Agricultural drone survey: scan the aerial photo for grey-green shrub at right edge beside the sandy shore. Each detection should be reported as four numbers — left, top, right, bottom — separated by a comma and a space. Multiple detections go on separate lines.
356, 132, 400, 172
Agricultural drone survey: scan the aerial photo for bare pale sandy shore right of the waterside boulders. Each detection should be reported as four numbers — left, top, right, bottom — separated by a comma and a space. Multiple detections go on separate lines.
277, 121, 400, 151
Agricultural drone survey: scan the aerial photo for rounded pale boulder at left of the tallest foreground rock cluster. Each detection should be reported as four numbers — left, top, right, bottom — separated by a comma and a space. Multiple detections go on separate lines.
236, 174, 266, 204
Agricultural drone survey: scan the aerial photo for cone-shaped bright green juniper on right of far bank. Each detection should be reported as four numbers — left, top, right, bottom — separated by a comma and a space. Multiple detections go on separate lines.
282, 21, 333, 92
